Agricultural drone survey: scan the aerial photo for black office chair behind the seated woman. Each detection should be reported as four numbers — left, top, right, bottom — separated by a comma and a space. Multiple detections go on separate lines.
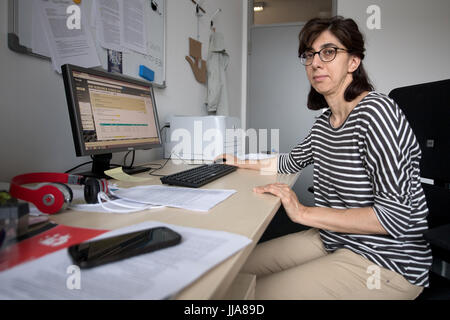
389, 79, 450, 300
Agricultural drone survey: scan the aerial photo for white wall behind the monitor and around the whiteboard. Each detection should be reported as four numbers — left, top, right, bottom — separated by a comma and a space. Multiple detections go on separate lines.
0, 0, 246, 181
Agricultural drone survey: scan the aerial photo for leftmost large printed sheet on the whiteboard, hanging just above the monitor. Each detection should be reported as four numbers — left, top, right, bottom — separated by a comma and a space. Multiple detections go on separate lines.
36, 0, 100, 73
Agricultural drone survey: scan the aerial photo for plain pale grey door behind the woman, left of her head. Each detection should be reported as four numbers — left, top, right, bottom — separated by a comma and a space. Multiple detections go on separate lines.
249, 24, 320, 205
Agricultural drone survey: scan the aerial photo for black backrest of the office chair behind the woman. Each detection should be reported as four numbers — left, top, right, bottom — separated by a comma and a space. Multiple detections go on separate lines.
389, 79, 450, 228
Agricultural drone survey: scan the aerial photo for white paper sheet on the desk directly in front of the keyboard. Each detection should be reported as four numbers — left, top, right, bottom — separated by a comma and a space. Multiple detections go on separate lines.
112, 185, 236, 212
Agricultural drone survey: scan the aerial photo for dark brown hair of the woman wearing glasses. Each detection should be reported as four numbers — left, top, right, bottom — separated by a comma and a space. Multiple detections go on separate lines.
298, 16, 373, 110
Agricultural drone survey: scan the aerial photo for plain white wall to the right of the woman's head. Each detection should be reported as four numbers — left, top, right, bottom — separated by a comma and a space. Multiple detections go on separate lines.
337, 0, 450, 94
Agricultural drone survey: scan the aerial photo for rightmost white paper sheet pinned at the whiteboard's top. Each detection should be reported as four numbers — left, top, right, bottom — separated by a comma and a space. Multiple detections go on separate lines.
119, 0, 147, 54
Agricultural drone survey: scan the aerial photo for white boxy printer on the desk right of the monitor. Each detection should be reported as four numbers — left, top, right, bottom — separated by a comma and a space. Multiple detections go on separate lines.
164, 116, 245, 160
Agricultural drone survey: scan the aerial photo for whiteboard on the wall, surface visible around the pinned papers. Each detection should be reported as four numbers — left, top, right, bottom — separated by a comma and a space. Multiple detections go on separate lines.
8, 0, 166, 88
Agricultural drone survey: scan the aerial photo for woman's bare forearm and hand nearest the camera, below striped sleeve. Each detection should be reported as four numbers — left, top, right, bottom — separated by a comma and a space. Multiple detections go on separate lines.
254, 183, 388, 235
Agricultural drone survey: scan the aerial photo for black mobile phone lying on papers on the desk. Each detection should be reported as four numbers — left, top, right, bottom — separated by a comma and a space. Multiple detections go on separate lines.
68, 227, 181, 268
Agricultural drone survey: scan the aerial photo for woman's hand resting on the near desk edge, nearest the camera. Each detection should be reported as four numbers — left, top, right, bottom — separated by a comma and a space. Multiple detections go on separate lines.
253, 183, 306, 223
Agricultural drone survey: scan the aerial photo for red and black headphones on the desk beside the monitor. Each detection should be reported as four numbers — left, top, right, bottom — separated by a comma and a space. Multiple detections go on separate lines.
9, 172, 108, 214
